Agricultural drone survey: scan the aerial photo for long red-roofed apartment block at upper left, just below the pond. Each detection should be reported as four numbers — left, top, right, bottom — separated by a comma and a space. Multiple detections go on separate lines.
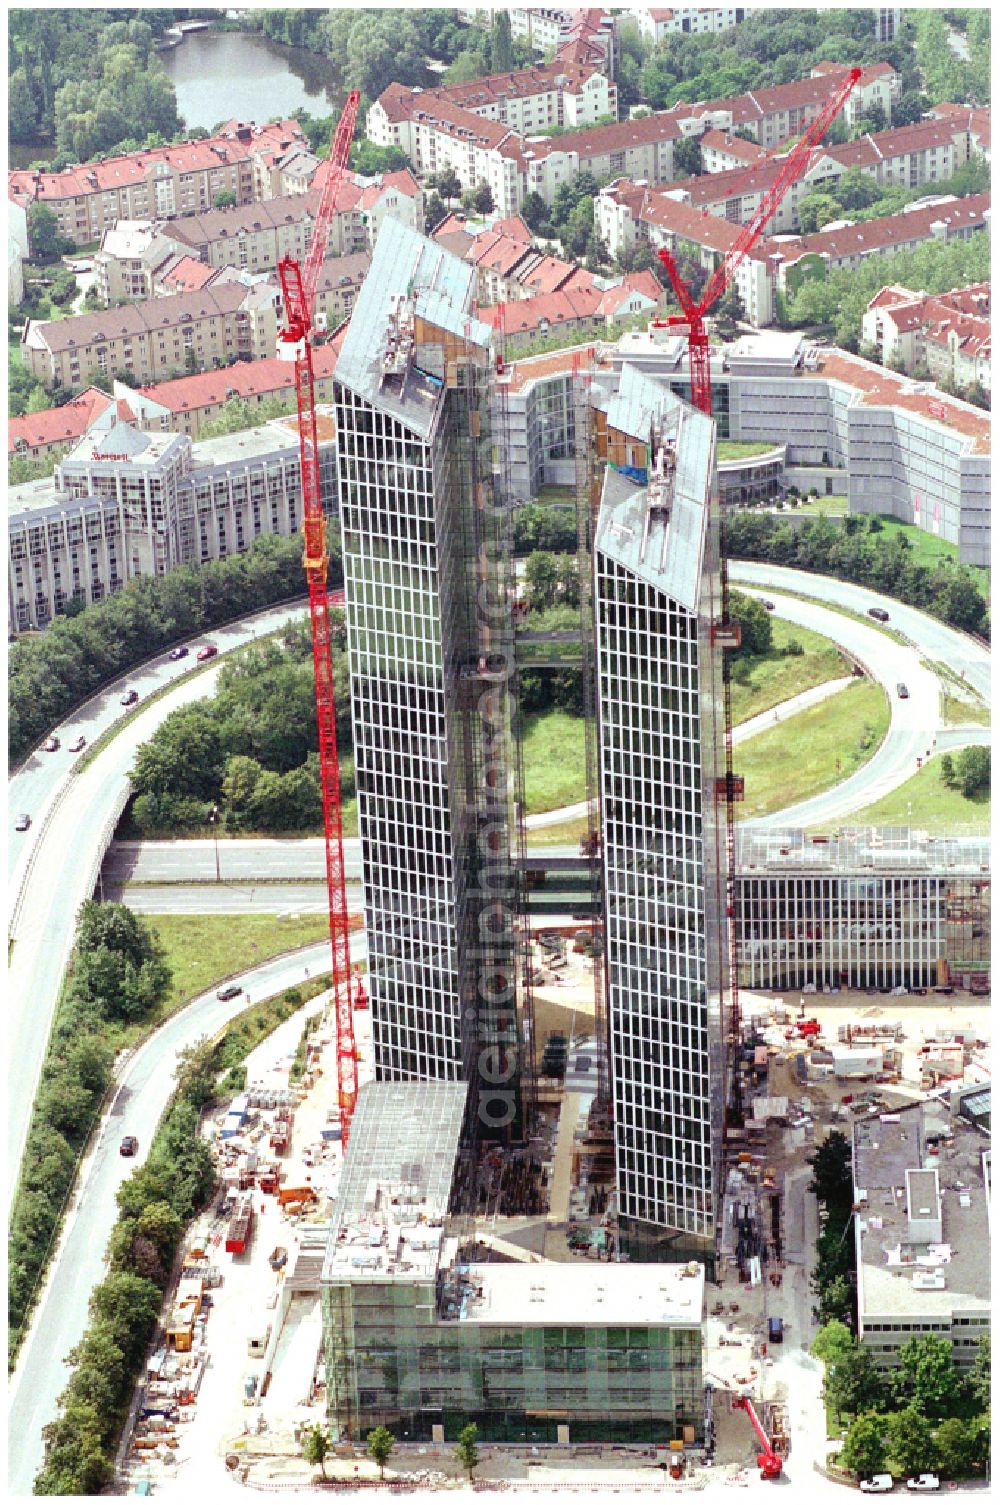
8, 120, 306, 245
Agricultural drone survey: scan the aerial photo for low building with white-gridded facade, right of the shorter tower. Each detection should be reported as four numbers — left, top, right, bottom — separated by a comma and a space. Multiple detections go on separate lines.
736, 826, 991, 992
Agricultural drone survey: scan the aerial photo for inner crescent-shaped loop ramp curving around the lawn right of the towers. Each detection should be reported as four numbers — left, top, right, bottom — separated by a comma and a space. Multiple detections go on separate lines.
740, 591, 940, 826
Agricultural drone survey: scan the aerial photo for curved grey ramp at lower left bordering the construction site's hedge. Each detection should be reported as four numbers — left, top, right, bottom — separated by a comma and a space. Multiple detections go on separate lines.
8, 936, 364, 1494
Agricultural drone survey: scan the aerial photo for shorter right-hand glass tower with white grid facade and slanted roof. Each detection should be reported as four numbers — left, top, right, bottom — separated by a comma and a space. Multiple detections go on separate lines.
595, 366, 727, 1270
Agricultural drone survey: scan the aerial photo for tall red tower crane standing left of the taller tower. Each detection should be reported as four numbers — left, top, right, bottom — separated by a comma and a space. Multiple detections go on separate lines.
277, 90, 361, 1148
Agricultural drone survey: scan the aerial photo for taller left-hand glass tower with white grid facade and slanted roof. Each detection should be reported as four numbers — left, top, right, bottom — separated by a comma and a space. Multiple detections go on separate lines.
336, 220, 520, 1133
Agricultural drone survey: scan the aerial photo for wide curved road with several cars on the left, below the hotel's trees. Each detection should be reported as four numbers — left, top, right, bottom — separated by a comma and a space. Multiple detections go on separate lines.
8, 607, 308, 1206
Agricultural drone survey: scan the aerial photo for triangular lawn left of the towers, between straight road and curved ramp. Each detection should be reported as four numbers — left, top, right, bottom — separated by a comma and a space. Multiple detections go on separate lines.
139, 915, 330, 1034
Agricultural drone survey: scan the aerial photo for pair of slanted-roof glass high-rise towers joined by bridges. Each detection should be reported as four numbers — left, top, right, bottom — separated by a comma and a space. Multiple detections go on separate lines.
336, 220, 730, 1266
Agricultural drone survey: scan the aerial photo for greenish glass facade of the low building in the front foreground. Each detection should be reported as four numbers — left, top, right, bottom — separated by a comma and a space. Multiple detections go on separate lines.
322, 1282, 702, 1442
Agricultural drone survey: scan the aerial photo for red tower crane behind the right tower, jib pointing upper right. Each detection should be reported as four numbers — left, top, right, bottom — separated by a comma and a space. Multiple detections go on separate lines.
654, 68, 861, 1127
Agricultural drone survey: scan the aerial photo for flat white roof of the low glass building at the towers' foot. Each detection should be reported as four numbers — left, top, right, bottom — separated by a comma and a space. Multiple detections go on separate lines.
459, 1261, 705, 1327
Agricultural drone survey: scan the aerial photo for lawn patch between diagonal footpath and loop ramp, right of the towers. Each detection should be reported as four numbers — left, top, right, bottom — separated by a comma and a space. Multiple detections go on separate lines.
736, 680, 890, 820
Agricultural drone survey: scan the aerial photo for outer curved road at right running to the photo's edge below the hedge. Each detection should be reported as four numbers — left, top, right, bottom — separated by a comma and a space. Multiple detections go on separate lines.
729, 560, 992, 704
